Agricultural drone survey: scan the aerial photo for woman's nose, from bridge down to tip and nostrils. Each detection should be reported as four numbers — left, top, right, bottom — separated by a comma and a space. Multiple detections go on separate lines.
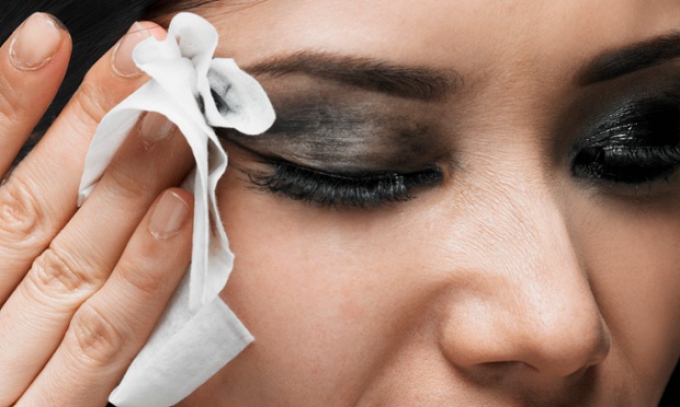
440, 182, 610, 378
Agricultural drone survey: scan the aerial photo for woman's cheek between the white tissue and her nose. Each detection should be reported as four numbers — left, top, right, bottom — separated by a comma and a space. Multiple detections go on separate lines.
211, 173, 436, 405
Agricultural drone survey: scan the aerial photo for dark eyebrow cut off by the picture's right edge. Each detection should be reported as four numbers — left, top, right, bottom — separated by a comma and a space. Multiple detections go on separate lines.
577, 32, 680, 86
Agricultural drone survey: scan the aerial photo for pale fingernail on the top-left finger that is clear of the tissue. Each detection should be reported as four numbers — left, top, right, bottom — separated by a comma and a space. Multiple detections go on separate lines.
9, 13, 64, 71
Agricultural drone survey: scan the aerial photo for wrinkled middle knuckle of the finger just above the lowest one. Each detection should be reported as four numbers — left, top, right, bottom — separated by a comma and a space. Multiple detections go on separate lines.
26, 246, 103, 298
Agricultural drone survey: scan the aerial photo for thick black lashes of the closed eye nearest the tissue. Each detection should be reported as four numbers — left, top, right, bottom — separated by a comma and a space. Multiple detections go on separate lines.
250, 161, 444, 209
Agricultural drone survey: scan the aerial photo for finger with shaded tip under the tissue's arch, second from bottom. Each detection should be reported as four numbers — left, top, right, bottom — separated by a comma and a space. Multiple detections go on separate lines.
0, 110, 193, 404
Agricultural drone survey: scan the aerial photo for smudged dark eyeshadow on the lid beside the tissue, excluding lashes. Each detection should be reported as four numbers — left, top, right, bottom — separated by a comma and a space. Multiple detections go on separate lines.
218, 96, 447, 173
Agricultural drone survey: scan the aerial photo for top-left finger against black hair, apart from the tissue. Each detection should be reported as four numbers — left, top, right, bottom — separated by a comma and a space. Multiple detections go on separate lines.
0, 13, 71, 175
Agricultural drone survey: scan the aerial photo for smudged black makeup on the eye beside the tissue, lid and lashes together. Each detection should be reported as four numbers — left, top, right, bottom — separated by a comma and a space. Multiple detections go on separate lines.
217, 89, 450, 209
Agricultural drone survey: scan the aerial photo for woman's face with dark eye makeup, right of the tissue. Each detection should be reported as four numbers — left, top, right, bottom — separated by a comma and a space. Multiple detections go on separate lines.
174, 0, 680, 407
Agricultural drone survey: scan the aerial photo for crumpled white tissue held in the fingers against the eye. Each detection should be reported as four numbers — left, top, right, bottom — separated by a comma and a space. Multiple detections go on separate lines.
79, 13, 275, 407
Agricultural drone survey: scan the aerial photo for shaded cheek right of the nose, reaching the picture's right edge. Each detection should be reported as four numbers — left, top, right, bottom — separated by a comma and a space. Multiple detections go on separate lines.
569, 194, 680, 387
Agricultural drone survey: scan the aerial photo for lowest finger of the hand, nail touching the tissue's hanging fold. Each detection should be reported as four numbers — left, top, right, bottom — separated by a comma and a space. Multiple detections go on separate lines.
17, 189, 192, 407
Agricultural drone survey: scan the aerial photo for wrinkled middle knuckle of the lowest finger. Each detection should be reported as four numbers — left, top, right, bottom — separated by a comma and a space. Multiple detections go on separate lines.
65, 302, 126, 366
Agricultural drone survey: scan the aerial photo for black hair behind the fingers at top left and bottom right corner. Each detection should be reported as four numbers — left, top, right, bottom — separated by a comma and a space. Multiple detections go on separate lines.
0, 0, 680, 407
